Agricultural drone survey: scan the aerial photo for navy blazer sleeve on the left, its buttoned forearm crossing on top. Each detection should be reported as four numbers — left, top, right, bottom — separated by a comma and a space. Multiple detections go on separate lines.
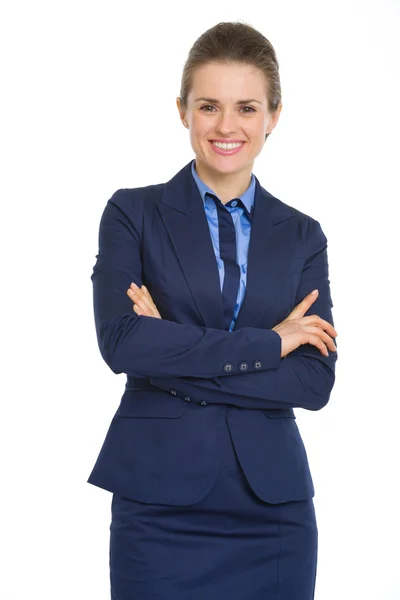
91, 191, 282, 378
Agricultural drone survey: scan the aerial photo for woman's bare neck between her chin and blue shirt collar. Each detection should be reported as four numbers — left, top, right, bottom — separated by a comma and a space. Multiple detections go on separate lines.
195, 158, 253, 204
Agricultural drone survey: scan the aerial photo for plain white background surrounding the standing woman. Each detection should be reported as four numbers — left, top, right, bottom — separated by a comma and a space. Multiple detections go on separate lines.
0, 0, 400, 600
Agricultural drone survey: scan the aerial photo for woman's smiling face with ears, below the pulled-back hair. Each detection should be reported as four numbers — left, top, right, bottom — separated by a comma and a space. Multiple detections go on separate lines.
177, 63, 282, 179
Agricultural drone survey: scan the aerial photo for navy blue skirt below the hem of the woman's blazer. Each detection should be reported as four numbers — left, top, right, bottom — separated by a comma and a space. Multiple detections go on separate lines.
110, 408, 318, 600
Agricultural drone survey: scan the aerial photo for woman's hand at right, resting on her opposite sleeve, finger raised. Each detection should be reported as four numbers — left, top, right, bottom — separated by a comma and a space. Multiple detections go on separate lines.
272, 291, 337, 358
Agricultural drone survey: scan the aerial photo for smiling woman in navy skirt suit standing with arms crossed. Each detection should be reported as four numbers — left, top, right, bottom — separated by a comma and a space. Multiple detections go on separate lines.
89, 23, 337, 600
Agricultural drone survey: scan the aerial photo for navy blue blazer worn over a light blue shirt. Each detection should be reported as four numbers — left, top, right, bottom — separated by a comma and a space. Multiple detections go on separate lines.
88, 163, 337, 505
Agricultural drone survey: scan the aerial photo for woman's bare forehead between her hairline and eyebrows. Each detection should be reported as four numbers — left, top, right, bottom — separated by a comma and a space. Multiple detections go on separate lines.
189, 63, 267, 101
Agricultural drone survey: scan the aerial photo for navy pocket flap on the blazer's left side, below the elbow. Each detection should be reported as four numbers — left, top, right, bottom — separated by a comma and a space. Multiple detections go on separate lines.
117, 390, 185, 419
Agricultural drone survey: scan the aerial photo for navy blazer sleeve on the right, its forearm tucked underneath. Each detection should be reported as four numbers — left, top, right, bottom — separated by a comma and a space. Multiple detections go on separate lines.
150, 218, 337, 410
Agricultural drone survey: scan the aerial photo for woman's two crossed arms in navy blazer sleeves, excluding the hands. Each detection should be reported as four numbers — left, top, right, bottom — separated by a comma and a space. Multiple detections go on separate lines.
91, 190, 337, 410
